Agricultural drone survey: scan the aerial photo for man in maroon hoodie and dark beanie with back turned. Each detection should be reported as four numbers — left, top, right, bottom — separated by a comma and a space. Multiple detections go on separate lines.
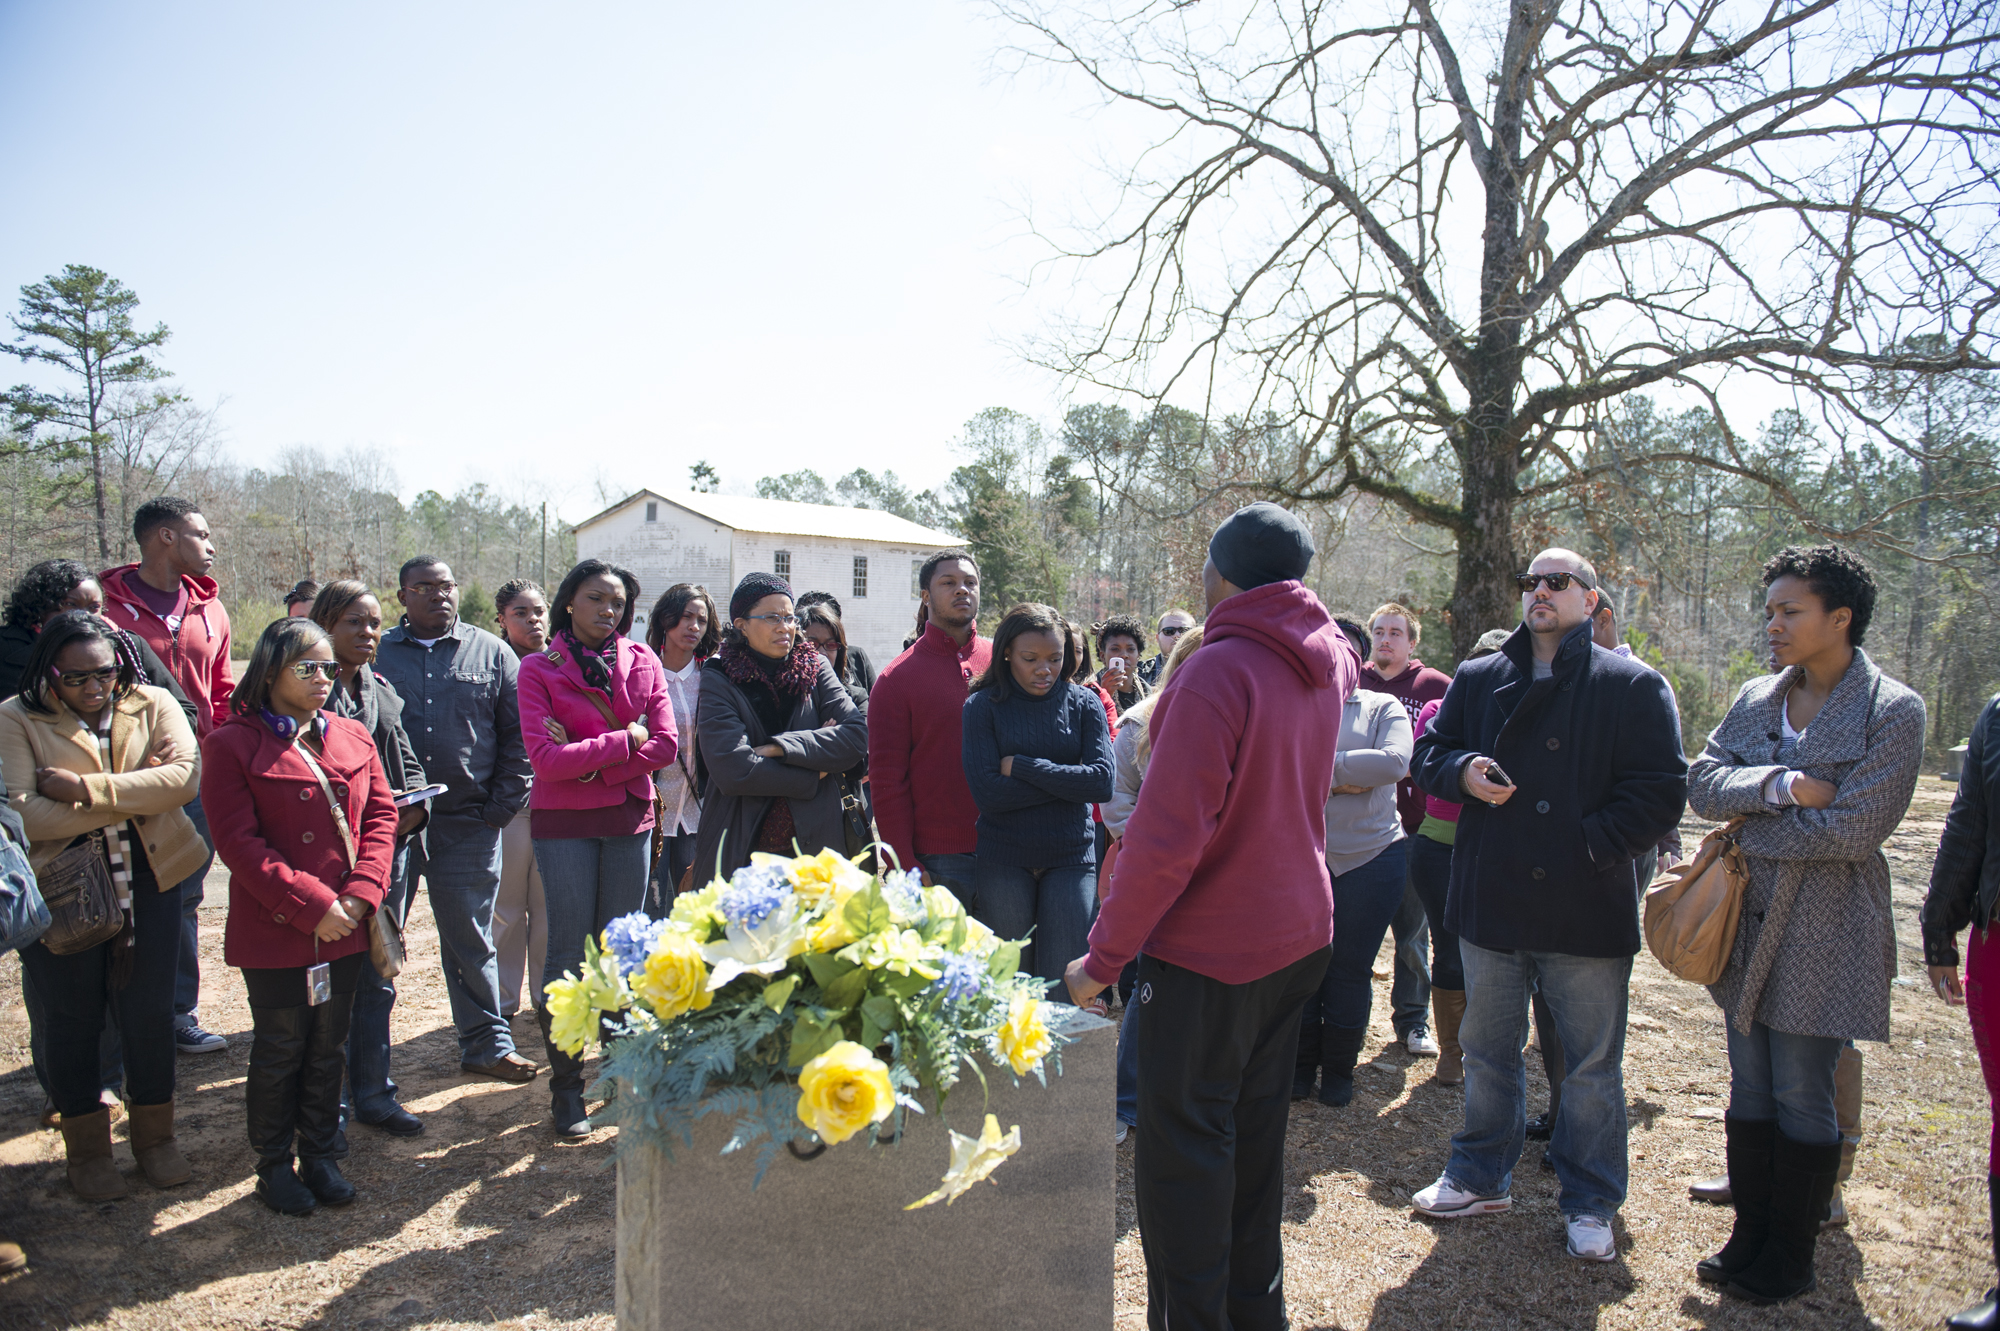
1066, 504, 1360, 1331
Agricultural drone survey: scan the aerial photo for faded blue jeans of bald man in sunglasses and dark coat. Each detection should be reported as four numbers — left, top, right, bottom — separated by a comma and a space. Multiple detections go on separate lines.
1446, 939, 1632, 1221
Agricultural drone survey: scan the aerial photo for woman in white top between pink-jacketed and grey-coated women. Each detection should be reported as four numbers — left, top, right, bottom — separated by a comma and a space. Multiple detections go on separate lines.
646, 582, 722, 903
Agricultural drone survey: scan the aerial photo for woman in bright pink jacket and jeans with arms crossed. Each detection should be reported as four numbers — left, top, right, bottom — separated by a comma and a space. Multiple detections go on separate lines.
520, 560, 680, 1137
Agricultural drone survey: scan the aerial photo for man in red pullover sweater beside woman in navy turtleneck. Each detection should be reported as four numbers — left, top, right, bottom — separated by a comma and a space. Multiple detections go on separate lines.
868, 550, 992, 909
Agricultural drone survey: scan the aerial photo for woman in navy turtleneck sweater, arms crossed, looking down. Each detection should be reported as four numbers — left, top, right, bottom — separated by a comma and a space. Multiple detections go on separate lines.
964, 604, 1112, 983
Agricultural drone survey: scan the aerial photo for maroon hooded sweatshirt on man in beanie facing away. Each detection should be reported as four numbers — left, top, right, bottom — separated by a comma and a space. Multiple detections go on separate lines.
1084, 582, 1360, 985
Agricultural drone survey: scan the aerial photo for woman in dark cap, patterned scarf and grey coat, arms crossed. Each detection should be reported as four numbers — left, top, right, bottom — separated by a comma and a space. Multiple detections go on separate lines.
694, 574, 868, 883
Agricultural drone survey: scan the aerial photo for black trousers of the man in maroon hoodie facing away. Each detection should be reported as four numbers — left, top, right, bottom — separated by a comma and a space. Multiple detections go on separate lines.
1132, 947, 1332, 1331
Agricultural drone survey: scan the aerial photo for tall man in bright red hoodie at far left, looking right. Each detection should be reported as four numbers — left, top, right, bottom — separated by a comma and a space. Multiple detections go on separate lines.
98, 496, 236, 1053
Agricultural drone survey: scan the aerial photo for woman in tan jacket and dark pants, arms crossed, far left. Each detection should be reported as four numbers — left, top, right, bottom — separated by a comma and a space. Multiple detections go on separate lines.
0, 610, 208, 1201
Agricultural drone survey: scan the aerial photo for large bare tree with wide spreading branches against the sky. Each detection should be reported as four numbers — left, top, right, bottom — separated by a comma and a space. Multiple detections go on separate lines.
998, 0, 2000, 652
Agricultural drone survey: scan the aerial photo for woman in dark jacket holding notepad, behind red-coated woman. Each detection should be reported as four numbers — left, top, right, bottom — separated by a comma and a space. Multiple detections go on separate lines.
310, 578, 432, 1137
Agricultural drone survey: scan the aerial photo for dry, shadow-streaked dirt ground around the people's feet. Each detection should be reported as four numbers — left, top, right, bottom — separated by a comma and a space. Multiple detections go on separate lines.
0, 777, 1994, 1331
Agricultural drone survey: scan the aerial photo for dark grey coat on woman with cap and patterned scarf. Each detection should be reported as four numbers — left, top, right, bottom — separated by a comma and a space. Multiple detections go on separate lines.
694, 658, 868, 885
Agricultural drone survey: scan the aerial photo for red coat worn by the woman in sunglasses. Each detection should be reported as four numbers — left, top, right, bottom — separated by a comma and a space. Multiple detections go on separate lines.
202, 713, 396, 967
